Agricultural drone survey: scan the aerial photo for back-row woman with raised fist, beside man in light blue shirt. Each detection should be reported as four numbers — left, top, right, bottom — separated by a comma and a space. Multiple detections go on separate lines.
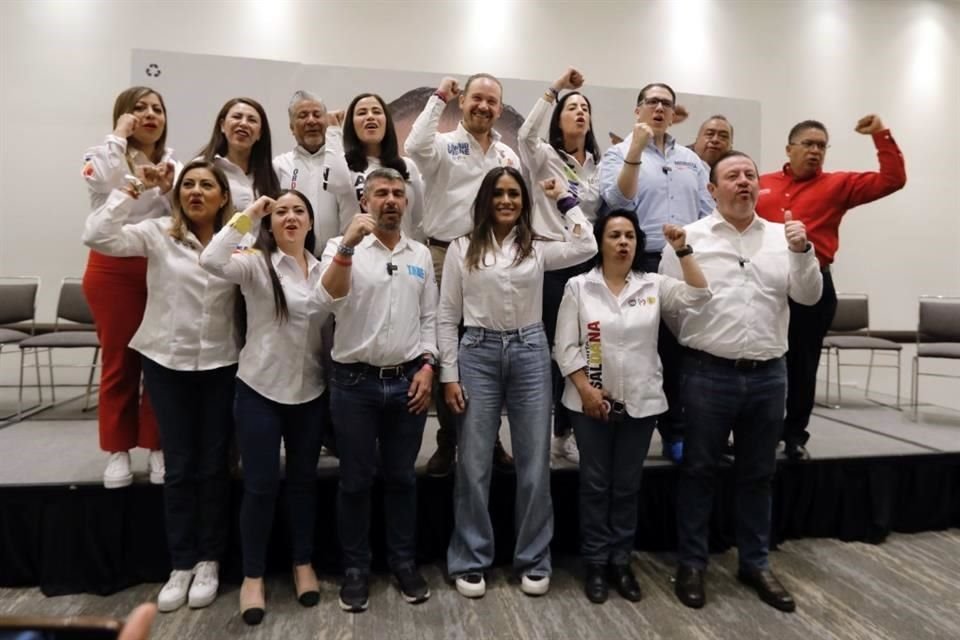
517, 67, 600, 464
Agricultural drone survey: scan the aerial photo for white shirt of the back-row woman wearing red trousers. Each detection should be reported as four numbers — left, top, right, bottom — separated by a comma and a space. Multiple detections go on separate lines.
83, 133, 183, 224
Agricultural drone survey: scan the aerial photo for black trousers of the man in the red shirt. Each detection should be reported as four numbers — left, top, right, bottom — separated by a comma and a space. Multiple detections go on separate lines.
783, 267, 837, 445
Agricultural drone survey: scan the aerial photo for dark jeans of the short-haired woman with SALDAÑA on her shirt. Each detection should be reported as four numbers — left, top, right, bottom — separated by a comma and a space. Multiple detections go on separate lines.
570, 411, 657, 565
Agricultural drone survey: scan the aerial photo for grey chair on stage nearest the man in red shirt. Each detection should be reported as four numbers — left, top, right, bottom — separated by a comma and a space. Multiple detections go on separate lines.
823, 293, 903, 409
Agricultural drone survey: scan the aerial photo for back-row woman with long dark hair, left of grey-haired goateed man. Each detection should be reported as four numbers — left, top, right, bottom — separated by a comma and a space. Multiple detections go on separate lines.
200, 98, 280, 211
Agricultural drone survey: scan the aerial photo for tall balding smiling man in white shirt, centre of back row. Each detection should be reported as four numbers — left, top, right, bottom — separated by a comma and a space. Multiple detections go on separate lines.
403, 73, 520, 476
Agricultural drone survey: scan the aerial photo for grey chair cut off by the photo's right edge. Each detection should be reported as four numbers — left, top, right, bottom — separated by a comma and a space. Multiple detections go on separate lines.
911, 296, 960, 417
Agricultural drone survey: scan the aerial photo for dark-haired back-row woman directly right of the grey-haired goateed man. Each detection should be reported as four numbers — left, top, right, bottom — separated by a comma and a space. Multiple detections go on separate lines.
324, 93, 426, 242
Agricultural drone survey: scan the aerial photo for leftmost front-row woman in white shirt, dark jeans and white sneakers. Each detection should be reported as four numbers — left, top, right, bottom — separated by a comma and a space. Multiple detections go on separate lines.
83, 160, 239, 611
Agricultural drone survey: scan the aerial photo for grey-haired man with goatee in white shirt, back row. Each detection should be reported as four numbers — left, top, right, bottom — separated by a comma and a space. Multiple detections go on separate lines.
273, 89, 340, 251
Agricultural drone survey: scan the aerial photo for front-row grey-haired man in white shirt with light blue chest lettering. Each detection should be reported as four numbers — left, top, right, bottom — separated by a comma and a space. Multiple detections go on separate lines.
316, 168, 437, 612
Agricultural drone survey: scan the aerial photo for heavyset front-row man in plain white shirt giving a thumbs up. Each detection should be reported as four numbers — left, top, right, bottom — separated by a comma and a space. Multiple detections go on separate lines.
660, 151, 823, 612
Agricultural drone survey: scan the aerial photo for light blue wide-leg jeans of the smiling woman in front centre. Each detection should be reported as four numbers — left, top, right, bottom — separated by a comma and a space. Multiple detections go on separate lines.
447, 322, 553, 577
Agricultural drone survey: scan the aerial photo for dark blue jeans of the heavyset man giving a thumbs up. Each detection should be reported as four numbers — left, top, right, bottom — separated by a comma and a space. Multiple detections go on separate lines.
677, 350, 786, 569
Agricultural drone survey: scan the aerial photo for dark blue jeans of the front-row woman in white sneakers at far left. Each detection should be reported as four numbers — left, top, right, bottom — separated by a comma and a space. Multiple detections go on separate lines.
143, 357, 237, 570
